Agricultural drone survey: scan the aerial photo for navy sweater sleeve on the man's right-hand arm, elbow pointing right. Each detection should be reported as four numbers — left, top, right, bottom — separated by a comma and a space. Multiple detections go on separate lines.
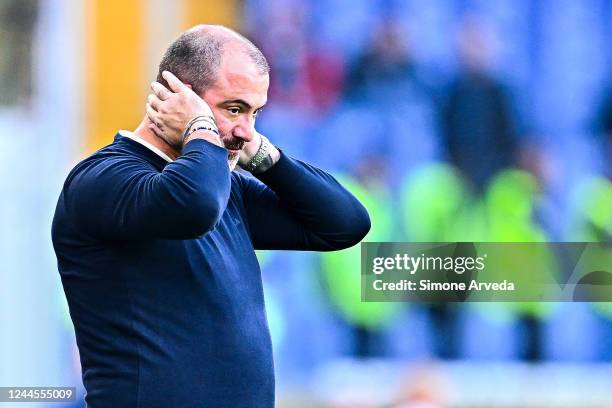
242, 153, 370, 251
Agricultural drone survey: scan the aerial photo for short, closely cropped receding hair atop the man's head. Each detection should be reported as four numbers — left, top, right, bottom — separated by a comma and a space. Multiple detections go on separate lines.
157, 25, 270, 95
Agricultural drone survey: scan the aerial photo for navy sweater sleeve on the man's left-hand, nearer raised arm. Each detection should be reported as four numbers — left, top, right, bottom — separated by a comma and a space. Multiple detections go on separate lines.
64, 139, 231, 240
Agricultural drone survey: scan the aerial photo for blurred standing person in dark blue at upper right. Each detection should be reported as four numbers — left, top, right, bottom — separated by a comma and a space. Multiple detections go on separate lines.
442, 15, 518, 193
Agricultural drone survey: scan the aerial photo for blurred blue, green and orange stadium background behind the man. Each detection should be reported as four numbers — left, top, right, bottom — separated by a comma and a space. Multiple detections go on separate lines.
0, 0, 612, 408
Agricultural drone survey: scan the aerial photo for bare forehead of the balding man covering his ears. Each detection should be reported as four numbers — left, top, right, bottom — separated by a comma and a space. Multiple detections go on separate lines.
205, 51, 270, 107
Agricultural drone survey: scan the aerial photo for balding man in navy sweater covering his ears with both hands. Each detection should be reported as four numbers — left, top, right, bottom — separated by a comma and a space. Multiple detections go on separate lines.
52, 26, 370, 408
